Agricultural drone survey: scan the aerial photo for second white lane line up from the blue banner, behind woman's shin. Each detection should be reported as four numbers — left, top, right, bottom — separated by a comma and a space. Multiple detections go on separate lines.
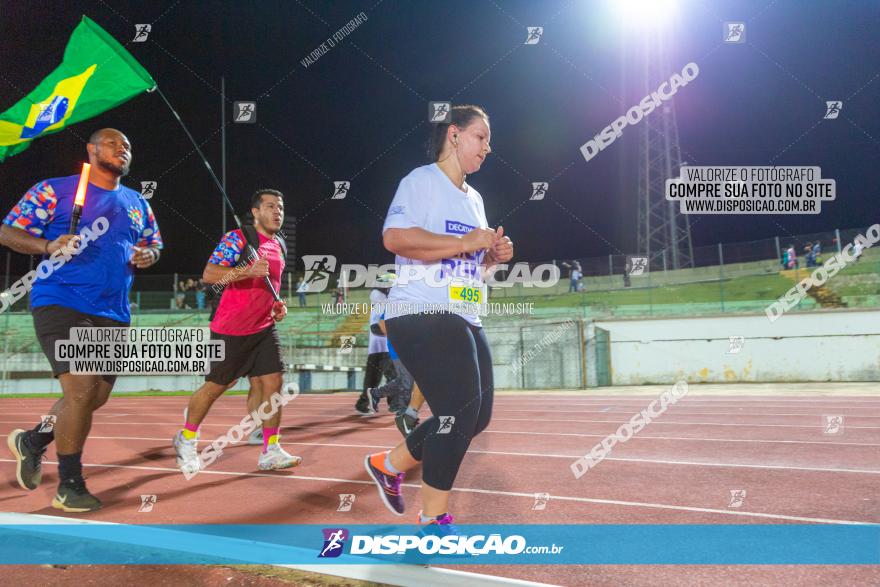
74, 436, 880, 475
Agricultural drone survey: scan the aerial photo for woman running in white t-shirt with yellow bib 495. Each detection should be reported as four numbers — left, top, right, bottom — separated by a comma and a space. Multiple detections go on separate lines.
364, 106, 513, 532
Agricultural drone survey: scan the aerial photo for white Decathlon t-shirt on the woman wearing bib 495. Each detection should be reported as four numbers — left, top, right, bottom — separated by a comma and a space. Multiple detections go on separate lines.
382, 163, 489, 326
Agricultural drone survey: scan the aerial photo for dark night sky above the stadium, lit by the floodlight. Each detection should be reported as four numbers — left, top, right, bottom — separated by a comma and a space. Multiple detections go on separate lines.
0, 0, 880, 274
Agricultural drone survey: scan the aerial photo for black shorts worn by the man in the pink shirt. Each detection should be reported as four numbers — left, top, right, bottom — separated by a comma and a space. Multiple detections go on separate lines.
205, 325, 284, 385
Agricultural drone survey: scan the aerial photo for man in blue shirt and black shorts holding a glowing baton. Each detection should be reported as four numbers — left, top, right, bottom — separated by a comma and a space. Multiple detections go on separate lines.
0, 128, 162, 512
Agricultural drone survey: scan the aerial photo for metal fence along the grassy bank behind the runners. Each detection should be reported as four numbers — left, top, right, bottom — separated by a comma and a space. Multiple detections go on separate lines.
4, 228, 880, 316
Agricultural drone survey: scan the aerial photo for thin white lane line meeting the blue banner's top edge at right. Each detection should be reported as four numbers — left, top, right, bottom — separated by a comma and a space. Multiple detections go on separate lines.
0, 459, 877, 525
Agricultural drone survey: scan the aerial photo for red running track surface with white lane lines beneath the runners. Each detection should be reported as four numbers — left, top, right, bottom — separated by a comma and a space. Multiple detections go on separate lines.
0, 393, 880, 585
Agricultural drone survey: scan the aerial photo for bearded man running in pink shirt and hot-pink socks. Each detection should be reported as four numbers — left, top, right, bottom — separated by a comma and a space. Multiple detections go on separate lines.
172, 189, 302, 474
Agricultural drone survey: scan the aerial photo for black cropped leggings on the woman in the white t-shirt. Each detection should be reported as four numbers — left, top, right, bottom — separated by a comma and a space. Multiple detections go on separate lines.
385, 314, 494, 491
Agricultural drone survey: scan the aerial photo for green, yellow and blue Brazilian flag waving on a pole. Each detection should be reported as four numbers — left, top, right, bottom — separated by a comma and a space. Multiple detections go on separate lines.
0, 16, 156, 161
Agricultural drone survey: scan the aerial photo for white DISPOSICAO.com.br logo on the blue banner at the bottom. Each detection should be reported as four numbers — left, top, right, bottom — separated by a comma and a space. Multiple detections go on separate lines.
318, 528, 564, 558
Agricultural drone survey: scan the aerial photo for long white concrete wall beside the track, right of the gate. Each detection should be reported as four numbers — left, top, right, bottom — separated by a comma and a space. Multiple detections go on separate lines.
595, 310, 880, 385
